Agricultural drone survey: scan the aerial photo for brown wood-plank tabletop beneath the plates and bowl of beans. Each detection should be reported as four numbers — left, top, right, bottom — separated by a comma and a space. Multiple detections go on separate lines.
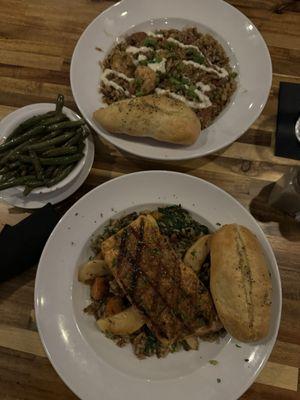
0, 0, 300, 400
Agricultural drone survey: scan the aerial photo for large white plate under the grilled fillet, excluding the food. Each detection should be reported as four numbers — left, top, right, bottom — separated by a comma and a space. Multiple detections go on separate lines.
35, 171, 281, 400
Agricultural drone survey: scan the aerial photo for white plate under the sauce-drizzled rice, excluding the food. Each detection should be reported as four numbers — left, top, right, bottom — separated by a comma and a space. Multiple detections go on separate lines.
71, 0, 272, 160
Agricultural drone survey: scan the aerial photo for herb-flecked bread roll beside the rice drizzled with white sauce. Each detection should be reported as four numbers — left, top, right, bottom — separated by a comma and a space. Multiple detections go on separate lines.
93, 95, 201, 145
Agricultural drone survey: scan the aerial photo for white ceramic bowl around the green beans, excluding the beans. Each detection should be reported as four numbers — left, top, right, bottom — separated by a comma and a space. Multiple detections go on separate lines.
0, 103, 87, 195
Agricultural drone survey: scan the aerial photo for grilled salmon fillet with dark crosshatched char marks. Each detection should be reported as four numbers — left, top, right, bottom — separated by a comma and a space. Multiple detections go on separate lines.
101, 215, 222, 343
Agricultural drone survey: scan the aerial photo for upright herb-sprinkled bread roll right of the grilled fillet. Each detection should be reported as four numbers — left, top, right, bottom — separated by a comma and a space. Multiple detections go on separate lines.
210, 224, 272, 342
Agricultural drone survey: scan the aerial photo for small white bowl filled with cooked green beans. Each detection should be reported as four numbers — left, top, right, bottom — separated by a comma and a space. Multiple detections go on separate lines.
0, 95, 90, 196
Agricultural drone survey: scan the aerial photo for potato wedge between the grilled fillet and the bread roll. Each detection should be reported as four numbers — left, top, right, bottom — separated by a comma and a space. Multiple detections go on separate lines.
183, 235, 211, 272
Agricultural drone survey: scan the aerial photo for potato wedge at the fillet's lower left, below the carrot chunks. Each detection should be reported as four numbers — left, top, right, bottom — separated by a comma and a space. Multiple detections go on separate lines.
97, 307, 145, 335
